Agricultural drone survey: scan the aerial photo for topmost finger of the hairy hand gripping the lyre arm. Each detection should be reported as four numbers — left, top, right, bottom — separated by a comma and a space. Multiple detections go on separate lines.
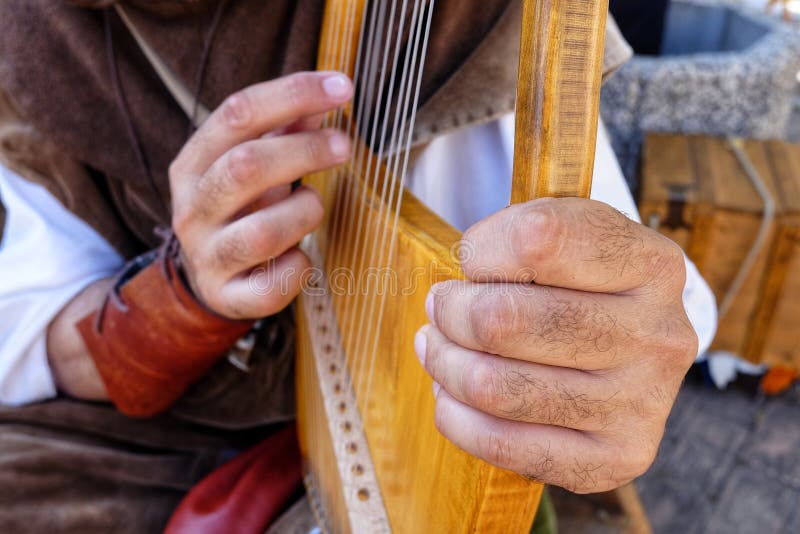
461, 198, 685, 293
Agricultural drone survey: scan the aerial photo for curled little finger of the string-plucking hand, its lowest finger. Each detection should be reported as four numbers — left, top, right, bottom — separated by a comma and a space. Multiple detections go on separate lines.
217, 248, 311, 319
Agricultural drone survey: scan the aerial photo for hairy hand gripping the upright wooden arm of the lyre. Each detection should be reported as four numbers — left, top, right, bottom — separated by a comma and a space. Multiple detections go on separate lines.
415, 199, 697, 493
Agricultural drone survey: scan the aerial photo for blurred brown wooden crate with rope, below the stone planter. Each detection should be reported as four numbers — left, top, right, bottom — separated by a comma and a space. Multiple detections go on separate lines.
639, 134, 800, 369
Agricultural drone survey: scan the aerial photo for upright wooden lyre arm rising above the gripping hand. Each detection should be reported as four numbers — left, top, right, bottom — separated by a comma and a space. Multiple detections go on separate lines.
511, 0, 608, 203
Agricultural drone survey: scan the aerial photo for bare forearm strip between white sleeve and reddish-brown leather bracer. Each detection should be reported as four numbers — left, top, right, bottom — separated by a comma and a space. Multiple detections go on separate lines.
47, 278, 113, 400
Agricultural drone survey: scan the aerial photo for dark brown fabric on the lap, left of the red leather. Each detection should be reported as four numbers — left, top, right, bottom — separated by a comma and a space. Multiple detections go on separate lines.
0, 399, 253, 534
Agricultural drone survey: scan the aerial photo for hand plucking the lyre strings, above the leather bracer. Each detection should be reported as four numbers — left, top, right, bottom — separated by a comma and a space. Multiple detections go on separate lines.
169, 72, 353, 319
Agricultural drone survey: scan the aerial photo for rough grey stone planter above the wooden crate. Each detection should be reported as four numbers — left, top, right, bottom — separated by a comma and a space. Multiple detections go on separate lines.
602, 0, 800, 188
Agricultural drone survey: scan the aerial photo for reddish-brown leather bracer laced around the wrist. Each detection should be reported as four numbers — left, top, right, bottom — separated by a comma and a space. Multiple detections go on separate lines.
77, 235, 254, 417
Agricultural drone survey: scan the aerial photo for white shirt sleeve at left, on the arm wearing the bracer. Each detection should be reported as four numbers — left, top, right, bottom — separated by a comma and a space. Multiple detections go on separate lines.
0, 165, 123, 405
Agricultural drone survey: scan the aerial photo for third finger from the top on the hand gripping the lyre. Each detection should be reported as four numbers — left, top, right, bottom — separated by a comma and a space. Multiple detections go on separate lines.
415, 326, 627, 432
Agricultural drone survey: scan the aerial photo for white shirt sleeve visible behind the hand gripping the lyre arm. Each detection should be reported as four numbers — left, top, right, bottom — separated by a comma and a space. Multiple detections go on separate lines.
408, 114, 717, 360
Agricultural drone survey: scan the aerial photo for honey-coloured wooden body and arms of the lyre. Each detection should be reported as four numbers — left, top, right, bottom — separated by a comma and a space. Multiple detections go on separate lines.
297, 0, 607, 533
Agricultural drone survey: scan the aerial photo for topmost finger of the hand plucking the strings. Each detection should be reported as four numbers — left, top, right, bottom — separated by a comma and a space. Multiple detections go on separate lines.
171, 72, 353, 176
